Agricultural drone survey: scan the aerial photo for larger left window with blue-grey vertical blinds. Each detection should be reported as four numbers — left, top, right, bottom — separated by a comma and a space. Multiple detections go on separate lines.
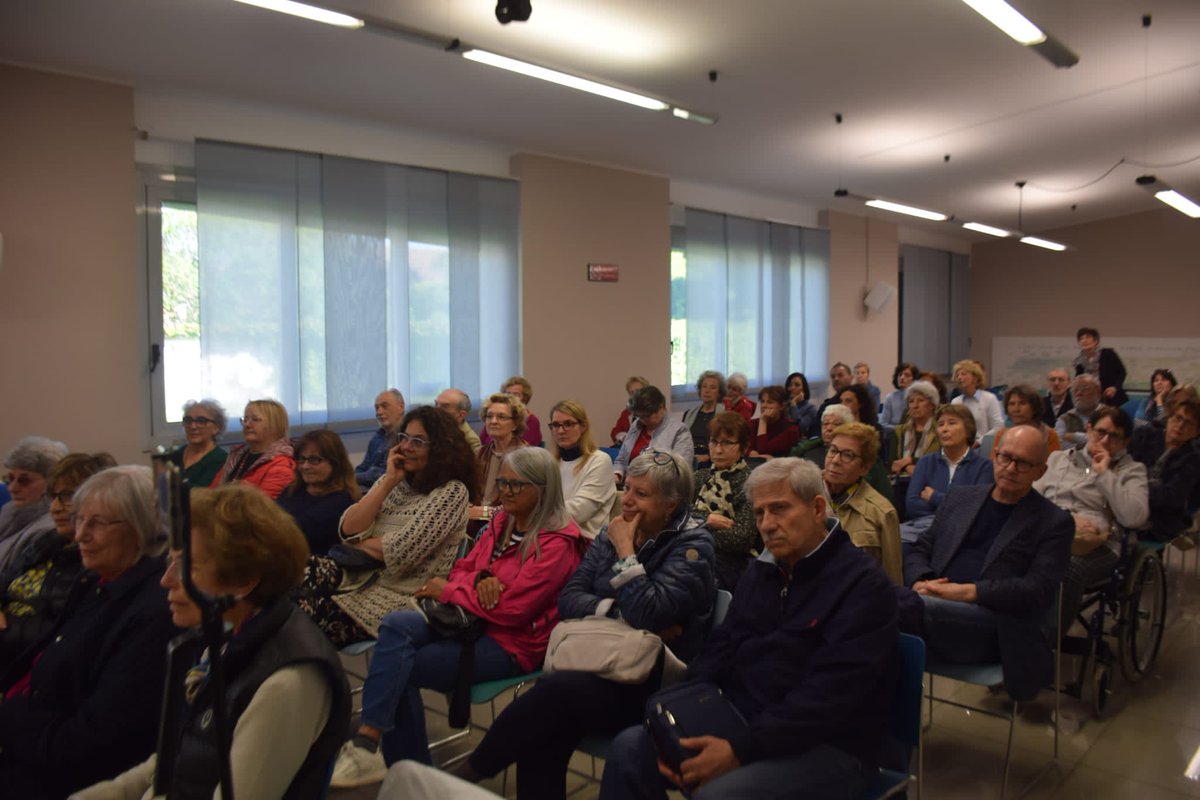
148, 142, 520, 434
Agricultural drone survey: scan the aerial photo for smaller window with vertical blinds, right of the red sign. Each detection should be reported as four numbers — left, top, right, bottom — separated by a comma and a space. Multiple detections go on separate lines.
671, 209, 829, 398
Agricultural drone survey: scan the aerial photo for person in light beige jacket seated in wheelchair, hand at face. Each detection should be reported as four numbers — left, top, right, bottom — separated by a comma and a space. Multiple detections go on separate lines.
1033, 405, 1150, 630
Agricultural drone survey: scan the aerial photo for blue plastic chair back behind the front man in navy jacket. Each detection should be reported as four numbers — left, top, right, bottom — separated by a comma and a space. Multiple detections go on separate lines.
860, 633, 925, 800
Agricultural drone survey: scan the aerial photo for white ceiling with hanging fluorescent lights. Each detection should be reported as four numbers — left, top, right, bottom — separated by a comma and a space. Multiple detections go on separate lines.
0, 0, 1200, 239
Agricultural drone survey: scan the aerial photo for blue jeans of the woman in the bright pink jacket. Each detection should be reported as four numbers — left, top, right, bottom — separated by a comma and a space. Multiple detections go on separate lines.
362, 610, 521, 764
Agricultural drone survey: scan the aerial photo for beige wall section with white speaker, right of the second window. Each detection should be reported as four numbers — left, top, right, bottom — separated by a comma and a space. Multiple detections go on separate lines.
821, 211, 900, 395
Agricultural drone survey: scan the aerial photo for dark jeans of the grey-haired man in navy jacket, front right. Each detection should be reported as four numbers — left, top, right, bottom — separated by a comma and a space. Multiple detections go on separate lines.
600, 726, 874, 800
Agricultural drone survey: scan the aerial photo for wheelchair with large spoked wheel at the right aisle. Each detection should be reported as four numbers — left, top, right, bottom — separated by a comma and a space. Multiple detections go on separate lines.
1062, 530, 1166, 717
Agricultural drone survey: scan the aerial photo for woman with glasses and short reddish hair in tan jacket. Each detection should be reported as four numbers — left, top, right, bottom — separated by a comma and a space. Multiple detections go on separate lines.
823, 422, 904, 585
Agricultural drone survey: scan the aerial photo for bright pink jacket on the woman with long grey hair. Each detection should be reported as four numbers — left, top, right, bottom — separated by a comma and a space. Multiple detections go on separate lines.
438, 511, 587, 672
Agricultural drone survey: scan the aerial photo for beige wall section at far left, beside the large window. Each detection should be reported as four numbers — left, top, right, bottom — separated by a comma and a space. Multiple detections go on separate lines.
0, 65, 145, 462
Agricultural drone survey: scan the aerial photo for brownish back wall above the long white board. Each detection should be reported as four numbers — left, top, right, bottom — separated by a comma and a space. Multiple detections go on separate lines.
971, 209, 1200, 363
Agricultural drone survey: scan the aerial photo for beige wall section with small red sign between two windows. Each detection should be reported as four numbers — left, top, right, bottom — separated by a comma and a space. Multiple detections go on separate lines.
512, 154, 671, 434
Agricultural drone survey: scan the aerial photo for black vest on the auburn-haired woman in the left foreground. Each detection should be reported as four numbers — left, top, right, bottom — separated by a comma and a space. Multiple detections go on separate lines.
170, 599, 350, 800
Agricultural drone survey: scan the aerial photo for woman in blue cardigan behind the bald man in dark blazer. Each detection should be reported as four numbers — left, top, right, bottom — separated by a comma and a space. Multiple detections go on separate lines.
900, 404, 992, 546
